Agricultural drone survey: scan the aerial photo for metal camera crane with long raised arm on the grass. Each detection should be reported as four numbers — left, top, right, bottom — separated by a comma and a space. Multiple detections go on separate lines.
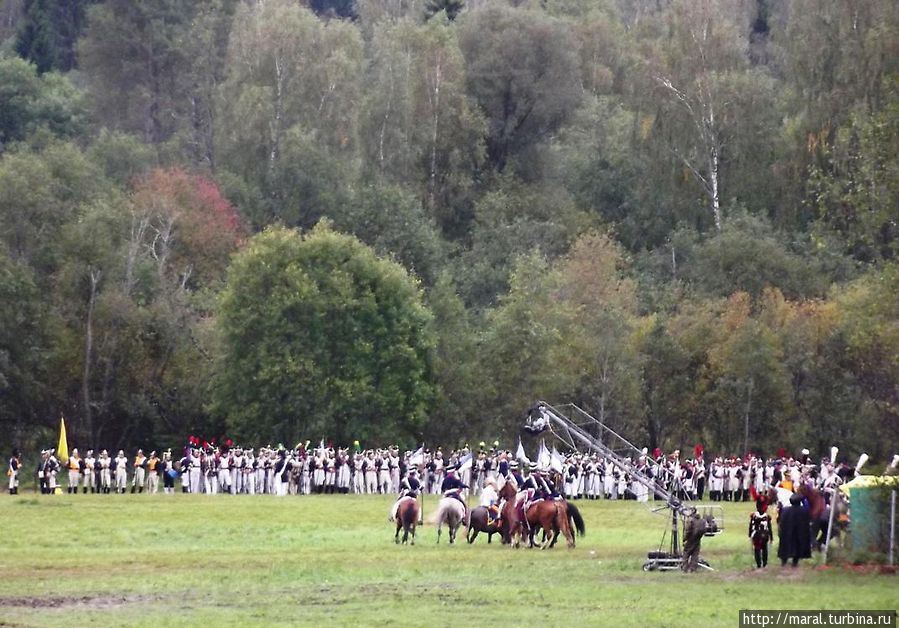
525, 401, 724, 571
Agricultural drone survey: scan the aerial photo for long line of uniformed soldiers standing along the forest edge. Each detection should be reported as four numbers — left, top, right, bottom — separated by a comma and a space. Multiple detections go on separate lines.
7, 442, 884, 501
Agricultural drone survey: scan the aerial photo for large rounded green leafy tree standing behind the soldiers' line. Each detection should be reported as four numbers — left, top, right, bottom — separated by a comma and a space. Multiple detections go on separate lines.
214, 224, 434, 444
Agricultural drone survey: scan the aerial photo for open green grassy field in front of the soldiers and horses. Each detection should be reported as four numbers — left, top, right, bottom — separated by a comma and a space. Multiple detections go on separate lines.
0, 494, 899, 628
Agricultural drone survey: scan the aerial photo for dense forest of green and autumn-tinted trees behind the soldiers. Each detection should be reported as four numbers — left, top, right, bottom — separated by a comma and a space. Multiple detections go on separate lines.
0, 0, 899, 459
